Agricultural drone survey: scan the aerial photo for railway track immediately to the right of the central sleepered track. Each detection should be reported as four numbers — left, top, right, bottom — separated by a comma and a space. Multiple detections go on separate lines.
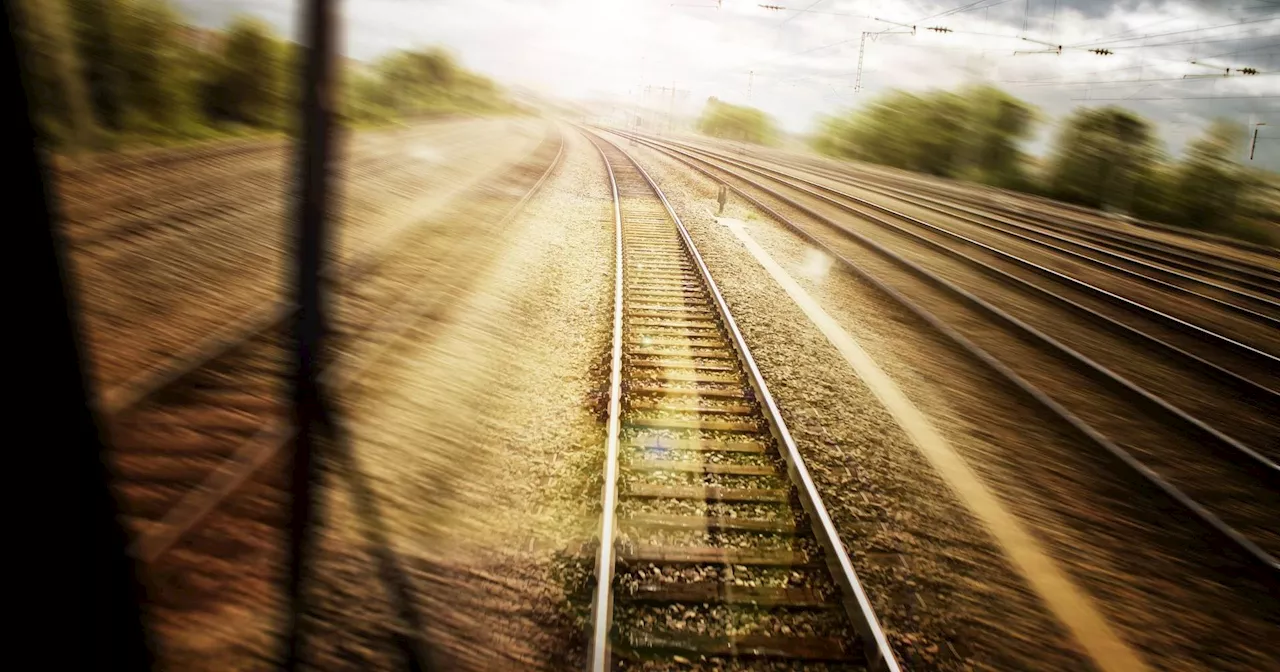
609, 129, 1280, 582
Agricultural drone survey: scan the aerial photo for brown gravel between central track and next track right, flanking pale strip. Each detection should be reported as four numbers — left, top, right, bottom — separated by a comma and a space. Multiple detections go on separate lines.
614, 137, 1276, 669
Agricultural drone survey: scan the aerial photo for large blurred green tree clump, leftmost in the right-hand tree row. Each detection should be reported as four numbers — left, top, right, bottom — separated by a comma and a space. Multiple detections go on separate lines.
814, 87, 1036, 188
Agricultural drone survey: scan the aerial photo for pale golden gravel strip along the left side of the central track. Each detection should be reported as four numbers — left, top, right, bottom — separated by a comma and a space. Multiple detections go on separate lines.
293, 122, 613, 669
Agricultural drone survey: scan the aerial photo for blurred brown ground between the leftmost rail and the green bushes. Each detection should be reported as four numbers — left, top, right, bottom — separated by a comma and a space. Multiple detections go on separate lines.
63, 119, 543, 396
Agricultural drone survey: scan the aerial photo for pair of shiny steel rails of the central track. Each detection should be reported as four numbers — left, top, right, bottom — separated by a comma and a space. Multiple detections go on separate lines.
588, 132, 901, 672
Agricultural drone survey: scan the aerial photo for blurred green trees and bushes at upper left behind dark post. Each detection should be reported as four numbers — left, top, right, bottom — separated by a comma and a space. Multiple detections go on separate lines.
13, 0, 513, 151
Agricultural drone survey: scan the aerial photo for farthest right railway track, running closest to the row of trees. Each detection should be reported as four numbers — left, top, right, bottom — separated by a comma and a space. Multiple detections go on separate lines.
711, 145, 1280, 289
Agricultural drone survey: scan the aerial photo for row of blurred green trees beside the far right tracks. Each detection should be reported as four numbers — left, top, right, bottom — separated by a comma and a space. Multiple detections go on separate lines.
810, 86, 1280, 246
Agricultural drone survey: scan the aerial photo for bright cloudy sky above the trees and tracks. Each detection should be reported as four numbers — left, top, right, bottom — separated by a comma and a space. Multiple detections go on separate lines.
183, 0, 1280, 170
